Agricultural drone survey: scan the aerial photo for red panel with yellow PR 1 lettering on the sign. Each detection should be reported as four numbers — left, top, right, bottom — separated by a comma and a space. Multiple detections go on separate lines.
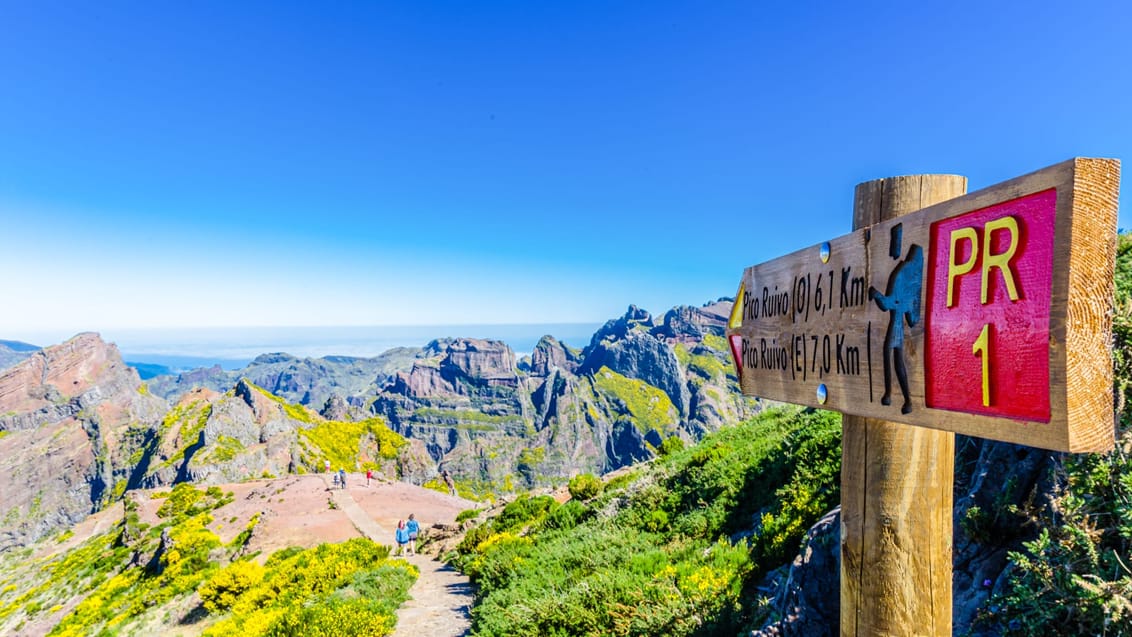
925, 189, 1057, 422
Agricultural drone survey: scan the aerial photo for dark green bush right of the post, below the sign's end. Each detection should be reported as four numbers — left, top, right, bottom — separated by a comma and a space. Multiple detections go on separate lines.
963, 234, 1132, 636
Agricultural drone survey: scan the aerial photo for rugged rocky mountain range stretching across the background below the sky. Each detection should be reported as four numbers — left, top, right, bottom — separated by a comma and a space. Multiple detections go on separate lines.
0, 300, 760, 551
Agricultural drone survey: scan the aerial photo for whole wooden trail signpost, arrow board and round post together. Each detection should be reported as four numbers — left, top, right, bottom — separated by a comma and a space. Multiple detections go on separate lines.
728, 158, 1120, 635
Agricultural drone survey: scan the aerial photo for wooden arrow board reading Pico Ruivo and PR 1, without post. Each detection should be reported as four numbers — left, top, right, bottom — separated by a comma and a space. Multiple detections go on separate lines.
728, 158, 1120, 451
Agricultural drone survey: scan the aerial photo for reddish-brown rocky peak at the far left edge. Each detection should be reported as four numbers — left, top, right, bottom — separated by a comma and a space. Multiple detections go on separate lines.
0, 334, 168, 551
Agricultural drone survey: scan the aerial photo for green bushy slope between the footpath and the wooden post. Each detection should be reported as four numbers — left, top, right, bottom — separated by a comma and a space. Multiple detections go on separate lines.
452, 408, 841, 636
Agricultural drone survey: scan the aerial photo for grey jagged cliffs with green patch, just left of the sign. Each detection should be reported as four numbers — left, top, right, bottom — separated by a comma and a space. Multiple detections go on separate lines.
371, 302, 757, 491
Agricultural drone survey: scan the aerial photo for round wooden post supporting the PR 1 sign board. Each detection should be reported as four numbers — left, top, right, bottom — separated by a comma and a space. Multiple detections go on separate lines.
841, 174, 967, 637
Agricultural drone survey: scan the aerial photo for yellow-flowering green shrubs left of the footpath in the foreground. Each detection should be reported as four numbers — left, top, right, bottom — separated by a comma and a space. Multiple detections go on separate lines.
0, 484, 418, 636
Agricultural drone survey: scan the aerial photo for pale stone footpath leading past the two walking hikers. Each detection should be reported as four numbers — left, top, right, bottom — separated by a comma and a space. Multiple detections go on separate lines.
324, 475, 472, 637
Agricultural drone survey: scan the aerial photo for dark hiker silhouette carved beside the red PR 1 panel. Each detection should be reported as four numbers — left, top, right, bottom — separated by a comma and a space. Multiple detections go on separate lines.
868, 224, 924, 414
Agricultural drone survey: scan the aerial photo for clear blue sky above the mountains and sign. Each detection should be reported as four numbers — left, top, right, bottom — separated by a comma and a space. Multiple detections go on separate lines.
0, 1, 1132, 338
